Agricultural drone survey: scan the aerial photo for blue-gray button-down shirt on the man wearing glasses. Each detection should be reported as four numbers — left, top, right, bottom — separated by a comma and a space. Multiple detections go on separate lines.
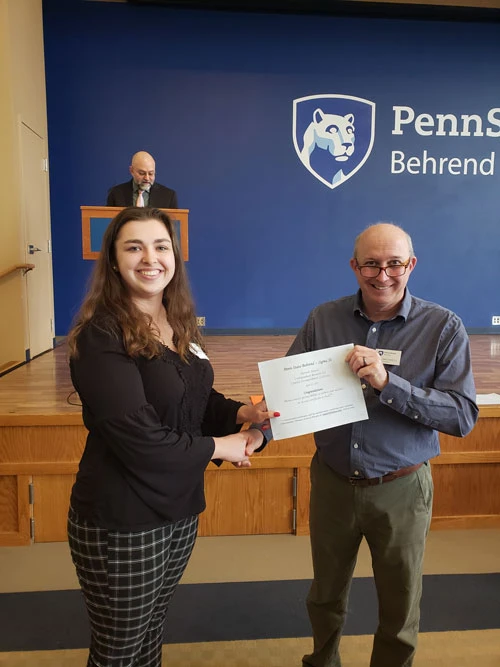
288, 289, 478, 477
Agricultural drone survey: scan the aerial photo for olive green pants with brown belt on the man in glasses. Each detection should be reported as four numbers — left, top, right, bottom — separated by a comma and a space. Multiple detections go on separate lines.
303, 453, 433, 667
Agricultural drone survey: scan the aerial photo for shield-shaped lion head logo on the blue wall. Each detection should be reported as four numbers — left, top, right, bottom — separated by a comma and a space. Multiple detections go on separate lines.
293, 95, 375, 190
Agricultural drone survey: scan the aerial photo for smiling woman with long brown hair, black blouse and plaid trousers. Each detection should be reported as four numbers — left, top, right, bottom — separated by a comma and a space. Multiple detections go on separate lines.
68, 208, 272, 667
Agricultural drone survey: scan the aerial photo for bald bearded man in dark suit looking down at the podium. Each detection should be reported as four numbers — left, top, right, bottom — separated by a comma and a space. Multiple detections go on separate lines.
106, 151, 179, 208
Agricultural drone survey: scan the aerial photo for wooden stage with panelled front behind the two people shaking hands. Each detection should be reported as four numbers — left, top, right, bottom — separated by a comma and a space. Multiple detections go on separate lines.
0, 336, 500, 545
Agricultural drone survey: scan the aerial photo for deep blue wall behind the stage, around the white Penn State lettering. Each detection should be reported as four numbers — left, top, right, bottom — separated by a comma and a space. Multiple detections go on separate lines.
44, 0, 500, 335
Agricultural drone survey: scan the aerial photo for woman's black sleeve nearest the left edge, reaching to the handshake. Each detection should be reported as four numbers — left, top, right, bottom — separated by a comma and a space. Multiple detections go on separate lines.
71, 326, 214, 480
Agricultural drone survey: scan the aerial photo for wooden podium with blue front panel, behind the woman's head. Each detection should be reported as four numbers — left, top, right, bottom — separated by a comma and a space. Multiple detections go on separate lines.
80, 206, 189, 262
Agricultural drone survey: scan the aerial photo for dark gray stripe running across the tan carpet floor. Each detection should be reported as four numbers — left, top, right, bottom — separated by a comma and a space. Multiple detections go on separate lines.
0, 573, 500, 651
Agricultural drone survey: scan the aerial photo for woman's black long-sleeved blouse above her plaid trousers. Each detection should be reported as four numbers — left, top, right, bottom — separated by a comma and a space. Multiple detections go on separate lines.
70, 325, 243, 531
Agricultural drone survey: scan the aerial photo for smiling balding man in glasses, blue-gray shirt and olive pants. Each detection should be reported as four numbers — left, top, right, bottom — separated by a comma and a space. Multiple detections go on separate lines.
288, 223, 478, 667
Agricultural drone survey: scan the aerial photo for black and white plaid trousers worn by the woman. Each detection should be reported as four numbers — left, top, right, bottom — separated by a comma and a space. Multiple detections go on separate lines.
68, 509, 198, 667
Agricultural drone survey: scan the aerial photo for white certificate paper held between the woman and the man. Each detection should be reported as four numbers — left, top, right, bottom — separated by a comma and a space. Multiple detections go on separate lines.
259, 344, 368, 440
